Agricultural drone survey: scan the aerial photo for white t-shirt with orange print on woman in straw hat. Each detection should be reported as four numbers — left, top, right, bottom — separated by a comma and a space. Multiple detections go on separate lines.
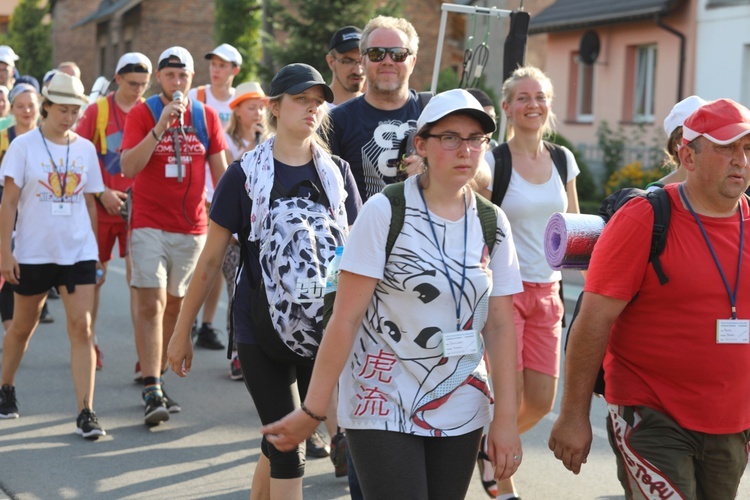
0, 129, 104, 266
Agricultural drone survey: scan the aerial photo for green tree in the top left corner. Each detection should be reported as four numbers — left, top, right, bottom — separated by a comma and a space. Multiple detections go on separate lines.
2, 0, 52, 81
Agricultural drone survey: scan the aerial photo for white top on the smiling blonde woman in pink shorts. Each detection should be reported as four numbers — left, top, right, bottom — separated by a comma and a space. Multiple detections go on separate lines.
485, 146, 581, 283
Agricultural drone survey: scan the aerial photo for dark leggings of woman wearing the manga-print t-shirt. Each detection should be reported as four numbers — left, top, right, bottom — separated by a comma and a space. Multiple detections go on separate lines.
346, 428, 482, 500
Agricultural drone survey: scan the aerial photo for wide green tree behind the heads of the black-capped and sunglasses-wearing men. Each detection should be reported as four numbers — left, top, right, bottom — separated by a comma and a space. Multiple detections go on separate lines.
266, 0, 401, 81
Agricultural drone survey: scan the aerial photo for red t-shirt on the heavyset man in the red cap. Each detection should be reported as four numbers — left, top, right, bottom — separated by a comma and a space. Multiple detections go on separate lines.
584, 184, 750, 434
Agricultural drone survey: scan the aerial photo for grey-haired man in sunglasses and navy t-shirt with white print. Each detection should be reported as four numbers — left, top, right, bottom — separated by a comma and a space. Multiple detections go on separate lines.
328, 16, 423, 201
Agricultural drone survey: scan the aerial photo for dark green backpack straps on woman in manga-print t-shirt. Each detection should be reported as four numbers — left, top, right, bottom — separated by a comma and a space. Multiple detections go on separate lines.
323, 182, 497, 327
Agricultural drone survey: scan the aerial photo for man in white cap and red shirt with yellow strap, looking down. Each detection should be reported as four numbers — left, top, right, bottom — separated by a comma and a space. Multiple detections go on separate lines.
76, 52, 151, 370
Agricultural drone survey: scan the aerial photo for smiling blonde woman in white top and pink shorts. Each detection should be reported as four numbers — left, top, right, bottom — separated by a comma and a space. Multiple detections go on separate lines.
479, 66, 579, 499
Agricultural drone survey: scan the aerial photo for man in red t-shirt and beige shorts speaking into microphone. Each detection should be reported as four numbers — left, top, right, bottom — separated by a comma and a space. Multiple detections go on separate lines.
121, 47, 227, 425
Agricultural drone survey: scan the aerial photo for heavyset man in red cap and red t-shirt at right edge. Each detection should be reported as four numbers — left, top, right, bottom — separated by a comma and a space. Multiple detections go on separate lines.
549, 99, 750, 499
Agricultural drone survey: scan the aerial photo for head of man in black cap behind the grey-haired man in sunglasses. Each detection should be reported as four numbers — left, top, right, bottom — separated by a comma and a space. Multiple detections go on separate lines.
326, 26, 365, 109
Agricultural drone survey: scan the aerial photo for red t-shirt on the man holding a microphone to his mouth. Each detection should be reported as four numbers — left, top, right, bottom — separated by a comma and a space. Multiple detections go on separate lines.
122, 97, 227, 234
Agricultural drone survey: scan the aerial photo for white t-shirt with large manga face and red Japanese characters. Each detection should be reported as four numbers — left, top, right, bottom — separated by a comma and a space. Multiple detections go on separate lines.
338, 177, 523, 436
